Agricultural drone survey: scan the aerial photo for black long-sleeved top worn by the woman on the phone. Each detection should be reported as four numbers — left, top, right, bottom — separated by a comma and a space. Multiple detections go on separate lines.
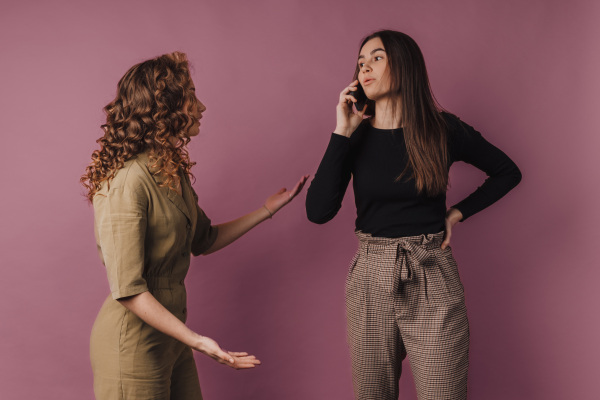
306, 113, 521, 237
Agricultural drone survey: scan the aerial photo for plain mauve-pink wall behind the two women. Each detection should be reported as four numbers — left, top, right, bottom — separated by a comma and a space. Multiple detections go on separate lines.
0, 0, 600, 400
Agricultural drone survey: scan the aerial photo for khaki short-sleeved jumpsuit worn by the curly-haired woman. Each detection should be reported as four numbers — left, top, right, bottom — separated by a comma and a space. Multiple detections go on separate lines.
90, 153, 217, 400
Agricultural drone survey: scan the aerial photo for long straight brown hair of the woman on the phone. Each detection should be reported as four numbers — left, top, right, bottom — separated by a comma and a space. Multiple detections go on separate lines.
354, 30, 448, 196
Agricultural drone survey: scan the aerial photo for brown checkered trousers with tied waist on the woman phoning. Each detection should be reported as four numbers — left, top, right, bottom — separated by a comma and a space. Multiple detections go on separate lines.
346, 231, 469, 400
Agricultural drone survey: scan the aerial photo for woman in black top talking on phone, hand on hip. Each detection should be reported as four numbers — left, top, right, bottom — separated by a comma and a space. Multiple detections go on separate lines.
306, 30, 521, 400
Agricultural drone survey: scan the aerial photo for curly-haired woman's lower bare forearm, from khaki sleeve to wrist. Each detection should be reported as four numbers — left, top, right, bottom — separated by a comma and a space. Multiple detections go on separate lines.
118, 292, 201, 348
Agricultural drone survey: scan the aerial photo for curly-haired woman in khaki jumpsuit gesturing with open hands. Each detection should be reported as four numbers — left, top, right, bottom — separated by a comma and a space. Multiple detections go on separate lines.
81, 52, 307, 400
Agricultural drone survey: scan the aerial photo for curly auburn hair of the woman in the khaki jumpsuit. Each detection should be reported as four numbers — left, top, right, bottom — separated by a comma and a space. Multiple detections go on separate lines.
80, 52, 198, 202
